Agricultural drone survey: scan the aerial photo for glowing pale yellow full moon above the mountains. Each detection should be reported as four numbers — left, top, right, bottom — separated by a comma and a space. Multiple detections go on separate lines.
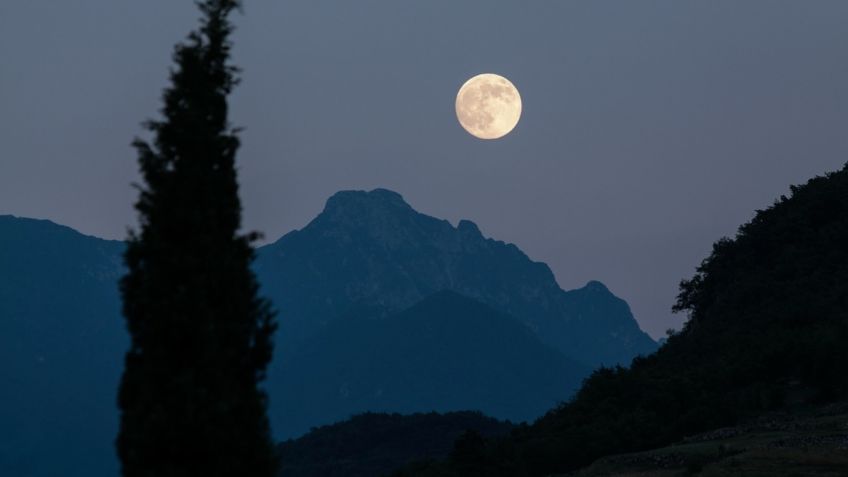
456, 73, 521, 139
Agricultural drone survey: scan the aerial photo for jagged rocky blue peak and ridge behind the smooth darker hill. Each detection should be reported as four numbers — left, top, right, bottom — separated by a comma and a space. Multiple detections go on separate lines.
256, 189, 656, 365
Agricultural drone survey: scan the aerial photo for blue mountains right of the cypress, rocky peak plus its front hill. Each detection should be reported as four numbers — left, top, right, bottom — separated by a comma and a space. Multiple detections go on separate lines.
256, 189, 656, 437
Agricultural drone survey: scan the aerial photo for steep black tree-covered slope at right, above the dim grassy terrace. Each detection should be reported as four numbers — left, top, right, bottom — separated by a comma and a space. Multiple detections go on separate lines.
398, 163, 848, 476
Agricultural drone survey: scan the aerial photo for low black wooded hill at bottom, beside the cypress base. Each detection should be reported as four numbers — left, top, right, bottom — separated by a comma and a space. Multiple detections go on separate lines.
279, 412, 514, 477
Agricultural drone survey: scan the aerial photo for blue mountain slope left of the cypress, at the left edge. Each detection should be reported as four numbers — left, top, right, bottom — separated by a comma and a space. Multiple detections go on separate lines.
0, 216, 128, 477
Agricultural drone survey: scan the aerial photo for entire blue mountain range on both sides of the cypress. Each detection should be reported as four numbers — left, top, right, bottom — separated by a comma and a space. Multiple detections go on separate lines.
0, 189, 656, 476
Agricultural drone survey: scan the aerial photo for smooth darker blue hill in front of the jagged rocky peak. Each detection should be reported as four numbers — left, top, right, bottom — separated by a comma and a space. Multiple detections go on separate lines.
271, 291, 590, 435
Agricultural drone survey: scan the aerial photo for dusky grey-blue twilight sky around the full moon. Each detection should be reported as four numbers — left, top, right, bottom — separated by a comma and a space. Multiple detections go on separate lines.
0, 0, 848, 337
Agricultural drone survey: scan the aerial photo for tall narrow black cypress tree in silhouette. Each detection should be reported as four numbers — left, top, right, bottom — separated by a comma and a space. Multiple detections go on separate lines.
116, 0, 276, 477
